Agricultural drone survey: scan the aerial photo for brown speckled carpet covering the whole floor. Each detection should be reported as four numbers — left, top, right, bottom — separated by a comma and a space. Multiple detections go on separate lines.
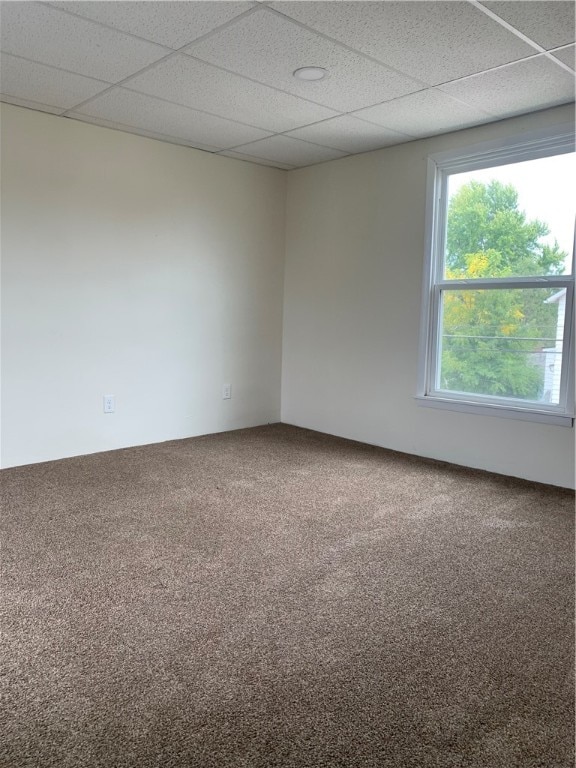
0, 425, 574, 768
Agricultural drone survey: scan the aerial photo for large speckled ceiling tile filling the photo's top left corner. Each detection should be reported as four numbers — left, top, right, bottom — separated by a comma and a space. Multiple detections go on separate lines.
0, 2, 169, 83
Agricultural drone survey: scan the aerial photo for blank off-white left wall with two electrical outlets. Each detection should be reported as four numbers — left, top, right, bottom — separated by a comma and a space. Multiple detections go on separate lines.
1, 105, 286, 467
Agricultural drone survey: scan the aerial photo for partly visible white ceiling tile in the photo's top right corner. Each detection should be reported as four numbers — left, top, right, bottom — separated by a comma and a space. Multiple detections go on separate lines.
482, 0, 574, 48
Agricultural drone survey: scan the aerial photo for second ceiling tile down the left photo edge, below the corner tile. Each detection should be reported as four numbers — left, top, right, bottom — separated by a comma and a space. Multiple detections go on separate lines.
0, 53, 110, 111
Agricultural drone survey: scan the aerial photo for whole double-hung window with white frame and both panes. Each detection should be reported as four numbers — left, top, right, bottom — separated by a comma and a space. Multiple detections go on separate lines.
418, 126, 576, 426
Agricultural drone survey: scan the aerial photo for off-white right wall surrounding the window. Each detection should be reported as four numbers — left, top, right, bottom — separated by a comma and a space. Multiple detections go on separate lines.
282, 107, 574, 487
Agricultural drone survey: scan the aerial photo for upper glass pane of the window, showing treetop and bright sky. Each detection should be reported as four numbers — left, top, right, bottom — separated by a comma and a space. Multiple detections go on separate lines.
444, 152, 576, 279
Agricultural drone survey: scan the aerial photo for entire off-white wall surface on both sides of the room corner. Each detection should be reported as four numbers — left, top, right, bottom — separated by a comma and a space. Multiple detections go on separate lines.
1, 105, 574, 486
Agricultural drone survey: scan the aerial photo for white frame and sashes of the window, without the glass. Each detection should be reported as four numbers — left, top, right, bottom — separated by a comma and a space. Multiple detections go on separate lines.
416, 123, 575, 427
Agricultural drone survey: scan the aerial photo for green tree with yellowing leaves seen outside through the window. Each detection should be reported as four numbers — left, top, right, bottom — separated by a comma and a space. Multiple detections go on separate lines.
441, 181, 566, 399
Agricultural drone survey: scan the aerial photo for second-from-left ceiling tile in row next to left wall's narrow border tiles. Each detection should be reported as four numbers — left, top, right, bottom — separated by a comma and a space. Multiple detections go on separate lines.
74, 88, 269, 149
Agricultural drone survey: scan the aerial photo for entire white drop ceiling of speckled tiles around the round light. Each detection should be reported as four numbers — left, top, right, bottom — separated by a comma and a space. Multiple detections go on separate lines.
0, 0, 575, 169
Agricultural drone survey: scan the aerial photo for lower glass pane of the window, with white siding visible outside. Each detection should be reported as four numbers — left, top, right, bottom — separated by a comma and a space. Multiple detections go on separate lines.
436, 288, 566, 405
